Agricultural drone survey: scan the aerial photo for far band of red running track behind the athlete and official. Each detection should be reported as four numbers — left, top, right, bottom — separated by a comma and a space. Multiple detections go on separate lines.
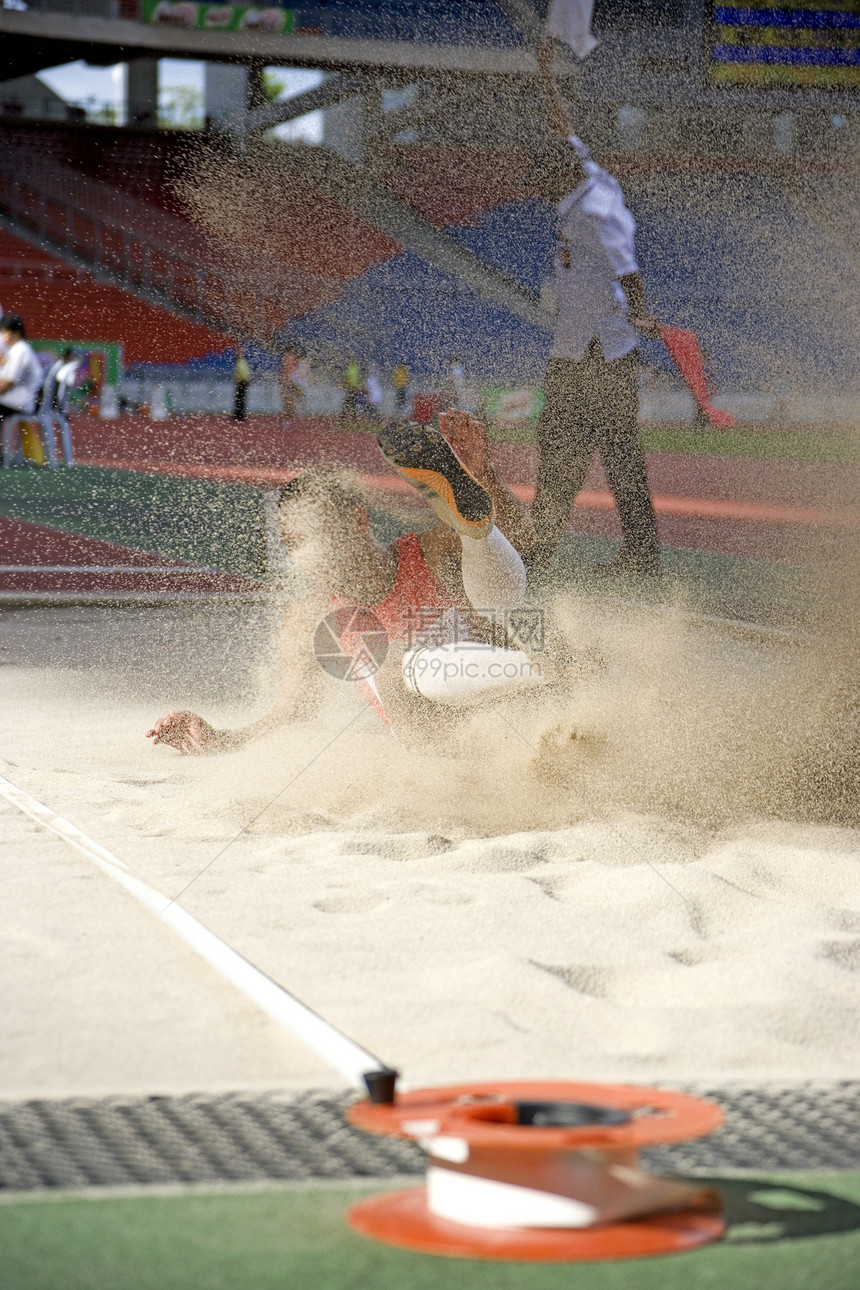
75, 415, 860, 562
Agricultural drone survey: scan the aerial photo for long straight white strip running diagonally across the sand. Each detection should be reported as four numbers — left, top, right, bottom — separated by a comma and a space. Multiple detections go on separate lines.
0, 775, 384, 1093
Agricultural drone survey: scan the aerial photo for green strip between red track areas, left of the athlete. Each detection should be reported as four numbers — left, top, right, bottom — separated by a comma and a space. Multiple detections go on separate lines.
0, 466, 266, 578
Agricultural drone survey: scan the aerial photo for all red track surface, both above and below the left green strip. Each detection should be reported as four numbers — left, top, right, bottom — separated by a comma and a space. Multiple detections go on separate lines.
0, 417, 860, 596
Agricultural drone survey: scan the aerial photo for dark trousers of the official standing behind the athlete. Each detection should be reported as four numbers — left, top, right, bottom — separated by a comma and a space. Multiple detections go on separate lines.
531, 339, 660, 570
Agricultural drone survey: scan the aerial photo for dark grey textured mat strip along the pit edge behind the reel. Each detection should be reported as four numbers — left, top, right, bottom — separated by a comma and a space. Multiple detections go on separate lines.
0, 1081, 860, 1191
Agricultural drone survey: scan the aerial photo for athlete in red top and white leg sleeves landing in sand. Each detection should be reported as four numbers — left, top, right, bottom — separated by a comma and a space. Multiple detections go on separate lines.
147, 412, 540, 753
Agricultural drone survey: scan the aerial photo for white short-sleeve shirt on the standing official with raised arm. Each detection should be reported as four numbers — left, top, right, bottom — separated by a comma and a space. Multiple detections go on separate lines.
552, 151, 640, 362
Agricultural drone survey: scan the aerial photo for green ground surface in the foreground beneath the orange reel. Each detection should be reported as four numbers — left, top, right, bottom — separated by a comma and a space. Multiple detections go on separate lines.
0, 1173, 860, 1290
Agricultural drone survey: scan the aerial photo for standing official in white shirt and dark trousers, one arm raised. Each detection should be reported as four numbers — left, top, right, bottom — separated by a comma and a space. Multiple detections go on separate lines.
529, 37, 660, 575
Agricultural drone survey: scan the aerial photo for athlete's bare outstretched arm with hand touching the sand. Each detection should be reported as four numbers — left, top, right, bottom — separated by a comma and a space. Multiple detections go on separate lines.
147, 596, 326, 755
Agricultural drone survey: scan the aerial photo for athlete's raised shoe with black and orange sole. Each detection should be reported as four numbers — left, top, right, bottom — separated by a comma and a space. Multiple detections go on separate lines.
378, 421, 494, 538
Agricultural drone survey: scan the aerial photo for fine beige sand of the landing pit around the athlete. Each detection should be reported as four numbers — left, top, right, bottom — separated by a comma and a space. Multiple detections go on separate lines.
0, 599, 860, 1097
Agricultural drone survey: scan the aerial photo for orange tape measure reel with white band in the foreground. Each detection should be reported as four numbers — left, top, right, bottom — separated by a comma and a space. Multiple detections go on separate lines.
347, 1081, 725, 1262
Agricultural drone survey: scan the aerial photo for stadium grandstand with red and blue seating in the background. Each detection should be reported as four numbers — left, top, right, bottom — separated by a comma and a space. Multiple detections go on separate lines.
0, 0, 857, 397
